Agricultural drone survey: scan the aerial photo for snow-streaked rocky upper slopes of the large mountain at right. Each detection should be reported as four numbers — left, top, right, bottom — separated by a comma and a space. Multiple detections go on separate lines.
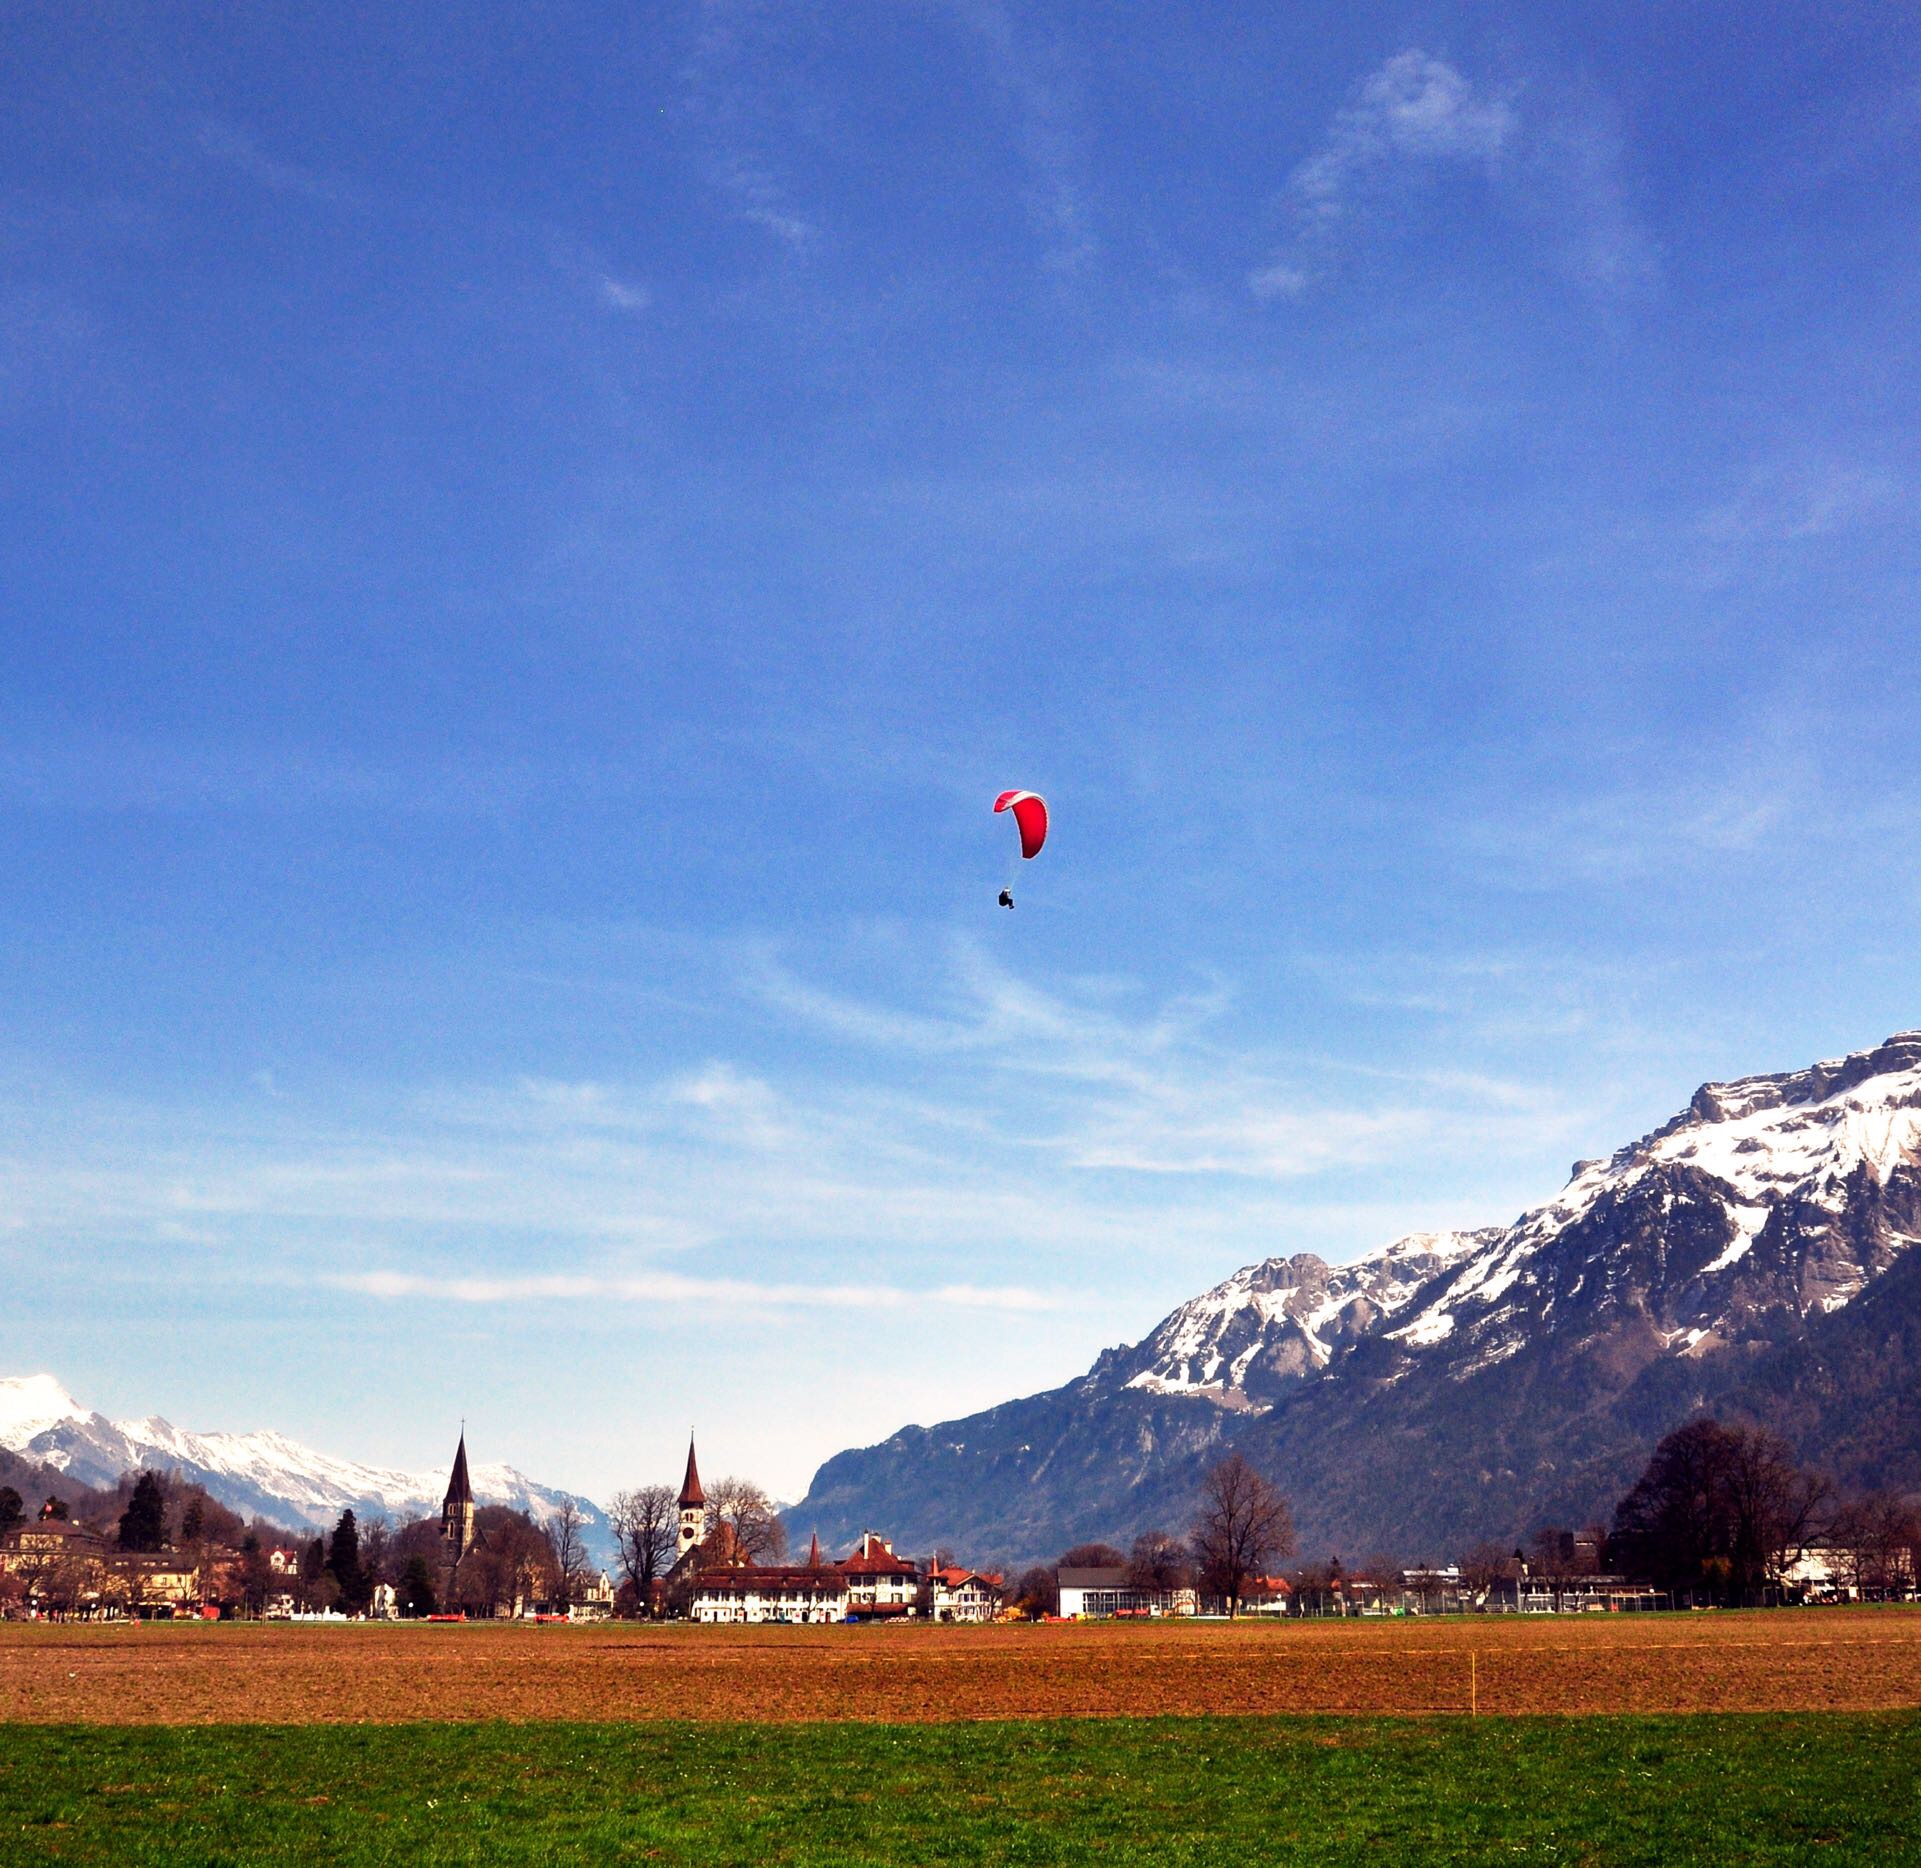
1089, 1032, 1921, 1413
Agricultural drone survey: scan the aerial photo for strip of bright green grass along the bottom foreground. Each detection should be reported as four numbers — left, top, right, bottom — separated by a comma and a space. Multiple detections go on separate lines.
0, 1712, 1921, 1868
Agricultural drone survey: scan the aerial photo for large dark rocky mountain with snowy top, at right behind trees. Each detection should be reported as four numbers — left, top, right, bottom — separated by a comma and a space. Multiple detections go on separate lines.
790, 1032, 1921, 1562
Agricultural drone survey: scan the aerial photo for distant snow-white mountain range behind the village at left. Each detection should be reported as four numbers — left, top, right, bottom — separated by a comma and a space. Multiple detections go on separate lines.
0, 1374, 613, 1562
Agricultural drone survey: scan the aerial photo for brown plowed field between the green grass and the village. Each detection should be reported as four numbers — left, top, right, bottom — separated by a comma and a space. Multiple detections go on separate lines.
0, 1609, 1921, 1724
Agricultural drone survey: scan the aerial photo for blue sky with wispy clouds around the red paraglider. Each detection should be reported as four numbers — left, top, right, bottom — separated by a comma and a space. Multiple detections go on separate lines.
0, 0, 1921, 1495
